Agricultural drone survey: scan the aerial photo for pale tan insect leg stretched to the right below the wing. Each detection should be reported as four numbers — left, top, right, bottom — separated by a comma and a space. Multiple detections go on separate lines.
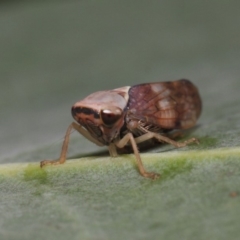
135, 132, 199, 147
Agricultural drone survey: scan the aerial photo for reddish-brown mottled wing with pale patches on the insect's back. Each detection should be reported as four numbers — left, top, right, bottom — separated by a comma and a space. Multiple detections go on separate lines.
127, 79, 202, 129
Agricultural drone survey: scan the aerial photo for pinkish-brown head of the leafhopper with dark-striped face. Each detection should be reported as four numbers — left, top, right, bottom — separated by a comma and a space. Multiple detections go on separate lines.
72, 87, 128, 145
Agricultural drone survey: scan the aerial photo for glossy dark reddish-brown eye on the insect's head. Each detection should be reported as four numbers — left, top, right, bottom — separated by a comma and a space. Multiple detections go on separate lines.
100, 107, 122, 127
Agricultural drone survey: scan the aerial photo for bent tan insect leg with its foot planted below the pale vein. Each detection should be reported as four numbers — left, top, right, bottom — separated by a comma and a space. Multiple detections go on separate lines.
115, 133, 159, 179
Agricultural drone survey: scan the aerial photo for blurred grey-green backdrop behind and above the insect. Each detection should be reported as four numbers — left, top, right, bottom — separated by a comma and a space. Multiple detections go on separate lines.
0, 0, 240, 162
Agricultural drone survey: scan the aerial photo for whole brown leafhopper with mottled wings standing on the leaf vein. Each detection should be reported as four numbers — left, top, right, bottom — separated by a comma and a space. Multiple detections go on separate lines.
40, 79, 202, 179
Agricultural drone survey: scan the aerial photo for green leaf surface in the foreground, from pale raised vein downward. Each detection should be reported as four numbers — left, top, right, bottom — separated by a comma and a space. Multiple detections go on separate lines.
0, 148, 240, 239
